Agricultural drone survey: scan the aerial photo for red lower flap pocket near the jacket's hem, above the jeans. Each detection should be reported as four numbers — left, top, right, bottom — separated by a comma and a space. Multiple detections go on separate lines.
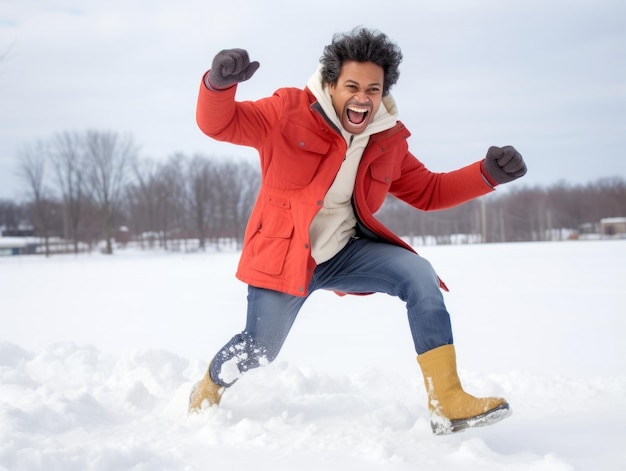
250, 214, 293, 275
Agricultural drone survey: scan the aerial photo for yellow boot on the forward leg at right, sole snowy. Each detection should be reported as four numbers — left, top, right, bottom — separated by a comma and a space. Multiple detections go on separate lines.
417, 345, 512, 435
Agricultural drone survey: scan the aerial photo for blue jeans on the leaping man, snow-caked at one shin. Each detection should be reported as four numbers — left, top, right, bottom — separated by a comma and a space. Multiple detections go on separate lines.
210, 238, 453, 387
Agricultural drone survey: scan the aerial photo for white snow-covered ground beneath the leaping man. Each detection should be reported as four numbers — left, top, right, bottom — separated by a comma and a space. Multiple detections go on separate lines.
0, 240, 626, 471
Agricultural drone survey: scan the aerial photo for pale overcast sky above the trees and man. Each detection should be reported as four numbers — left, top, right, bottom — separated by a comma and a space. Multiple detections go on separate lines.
0, 0, 626, 198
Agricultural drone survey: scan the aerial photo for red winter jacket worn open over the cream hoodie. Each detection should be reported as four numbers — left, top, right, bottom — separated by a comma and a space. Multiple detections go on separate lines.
196, 82, 492, 296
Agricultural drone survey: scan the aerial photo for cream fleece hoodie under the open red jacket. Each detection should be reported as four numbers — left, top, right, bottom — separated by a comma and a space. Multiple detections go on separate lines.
307, 68, 398, 264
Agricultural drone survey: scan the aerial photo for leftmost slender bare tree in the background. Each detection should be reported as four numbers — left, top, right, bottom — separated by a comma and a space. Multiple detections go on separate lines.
18, 141, 53, 256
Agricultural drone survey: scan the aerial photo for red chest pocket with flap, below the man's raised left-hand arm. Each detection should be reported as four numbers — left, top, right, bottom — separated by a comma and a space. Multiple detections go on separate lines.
272, 121, 330, 187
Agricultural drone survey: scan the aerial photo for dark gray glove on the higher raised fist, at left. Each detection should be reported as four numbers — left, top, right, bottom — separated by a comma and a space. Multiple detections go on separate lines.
206, 49, 260, 90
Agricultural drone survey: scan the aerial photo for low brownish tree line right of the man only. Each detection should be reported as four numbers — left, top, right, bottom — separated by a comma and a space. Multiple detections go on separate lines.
379, 177, 626, 244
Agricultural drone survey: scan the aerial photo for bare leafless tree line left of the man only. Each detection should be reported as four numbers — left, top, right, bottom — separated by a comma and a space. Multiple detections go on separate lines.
0, 130, 260, 254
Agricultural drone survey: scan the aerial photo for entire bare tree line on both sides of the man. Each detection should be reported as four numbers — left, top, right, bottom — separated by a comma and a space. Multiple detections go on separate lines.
0, 130, 626, 254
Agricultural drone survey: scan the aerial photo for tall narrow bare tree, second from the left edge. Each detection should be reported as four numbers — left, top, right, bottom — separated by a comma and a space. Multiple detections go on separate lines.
50, 132, 85, 253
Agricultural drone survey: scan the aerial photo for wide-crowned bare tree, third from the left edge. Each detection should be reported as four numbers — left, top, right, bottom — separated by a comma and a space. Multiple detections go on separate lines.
85, 131, 137, 254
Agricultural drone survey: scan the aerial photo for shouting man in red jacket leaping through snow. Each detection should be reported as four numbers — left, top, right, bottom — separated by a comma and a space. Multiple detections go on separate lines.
189, 28, 526, 434
